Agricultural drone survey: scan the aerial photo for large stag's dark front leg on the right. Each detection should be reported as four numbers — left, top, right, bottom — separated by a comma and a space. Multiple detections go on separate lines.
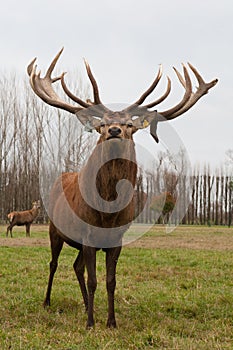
106, 247, 121, 328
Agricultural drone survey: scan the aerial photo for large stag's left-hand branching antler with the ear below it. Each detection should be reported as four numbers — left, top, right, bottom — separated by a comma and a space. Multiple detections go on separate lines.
27, 48, 107, 124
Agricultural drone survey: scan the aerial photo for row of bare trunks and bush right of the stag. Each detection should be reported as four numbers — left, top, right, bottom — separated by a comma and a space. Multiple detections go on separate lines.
138, 165, 233, 227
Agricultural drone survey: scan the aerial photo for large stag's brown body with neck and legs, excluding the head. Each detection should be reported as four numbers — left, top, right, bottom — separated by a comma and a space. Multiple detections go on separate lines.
44, 129, 137, 327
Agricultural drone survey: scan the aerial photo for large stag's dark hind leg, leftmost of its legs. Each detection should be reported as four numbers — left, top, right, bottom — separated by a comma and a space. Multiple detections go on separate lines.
44, 225, 64, 307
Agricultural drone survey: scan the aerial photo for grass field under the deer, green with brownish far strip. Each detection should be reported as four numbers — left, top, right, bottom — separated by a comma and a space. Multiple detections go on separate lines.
0, 225, 233, 350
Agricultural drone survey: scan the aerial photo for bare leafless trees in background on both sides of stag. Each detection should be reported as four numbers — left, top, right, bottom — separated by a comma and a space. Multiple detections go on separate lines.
0, 74, 233, 225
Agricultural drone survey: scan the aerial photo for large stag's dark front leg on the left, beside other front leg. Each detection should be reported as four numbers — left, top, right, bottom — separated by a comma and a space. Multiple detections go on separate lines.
83, 246, 97, 329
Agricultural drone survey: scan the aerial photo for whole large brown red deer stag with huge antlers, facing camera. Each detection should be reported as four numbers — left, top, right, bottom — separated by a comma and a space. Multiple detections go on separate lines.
27, 49, 217, 328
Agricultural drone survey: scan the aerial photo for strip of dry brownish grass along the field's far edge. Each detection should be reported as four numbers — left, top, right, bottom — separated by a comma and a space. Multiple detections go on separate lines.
0, 225, 233, 251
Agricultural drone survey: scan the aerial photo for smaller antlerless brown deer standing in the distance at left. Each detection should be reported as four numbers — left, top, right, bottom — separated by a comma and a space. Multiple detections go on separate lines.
6, 201, 40, 237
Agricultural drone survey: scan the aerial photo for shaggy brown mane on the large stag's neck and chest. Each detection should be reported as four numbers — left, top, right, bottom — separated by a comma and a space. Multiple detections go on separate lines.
78, 139, 137, 227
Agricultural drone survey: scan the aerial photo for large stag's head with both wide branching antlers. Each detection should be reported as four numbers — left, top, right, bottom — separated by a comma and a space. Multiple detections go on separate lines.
27, 49, 218, 142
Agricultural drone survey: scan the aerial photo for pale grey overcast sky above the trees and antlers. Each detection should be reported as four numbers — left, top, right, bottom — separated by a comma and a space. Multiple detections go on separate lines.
0, 0, 233, 170
